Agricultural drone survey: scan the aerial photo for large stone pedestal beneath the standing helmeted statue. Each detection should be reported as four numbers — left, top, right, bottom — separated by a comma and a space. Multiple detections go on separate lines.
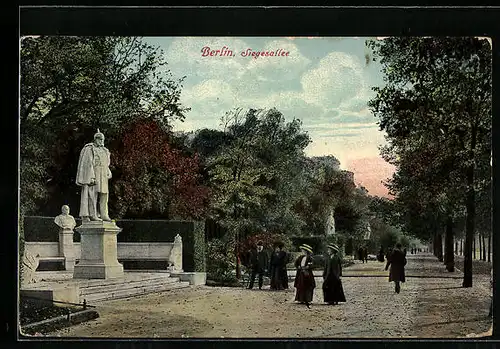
73, 221, 123, 279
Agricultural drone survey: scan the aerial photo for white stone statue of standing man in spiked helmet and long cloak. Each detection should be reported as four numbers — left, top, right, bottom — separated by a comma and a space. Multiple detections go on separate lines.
76, 129, 111, 221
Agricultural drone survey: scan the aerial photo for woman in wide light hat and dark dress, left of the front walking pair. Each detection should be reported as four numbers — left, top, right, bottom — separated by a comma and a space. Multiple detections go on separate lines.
294, 244, 316, 308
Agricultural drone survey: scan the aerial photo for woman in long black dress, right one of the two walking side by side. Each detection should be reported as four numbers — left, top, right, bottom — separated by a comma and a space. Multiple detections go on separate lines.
323, 244, 346, 305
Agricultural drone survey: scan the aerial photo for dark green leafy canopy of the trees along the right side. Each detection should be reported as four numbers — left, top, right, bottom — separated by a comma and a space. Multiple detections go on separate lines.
368, 38, 492, 245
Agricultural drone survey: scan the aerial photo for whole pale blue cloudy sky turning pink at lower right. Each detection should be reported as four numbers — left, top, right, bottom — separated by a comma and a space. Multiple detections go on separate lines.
145, 37, 393, 196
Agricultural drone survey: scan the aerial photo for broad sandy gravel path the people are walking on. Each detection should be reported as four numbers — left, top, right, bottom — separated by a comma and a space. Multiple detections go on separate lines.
47, 254, 491, 338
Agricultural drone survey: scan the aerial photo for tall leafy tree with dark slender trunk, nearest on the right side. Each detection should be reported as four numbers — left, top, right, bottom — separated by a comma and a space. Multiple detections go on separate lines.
368, 38, 491, 287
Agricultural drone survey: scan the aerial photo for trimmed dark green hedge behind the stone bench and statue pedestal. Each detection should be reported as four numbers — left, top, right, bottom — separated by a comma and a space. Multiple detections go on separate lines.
24, 216, 206, 272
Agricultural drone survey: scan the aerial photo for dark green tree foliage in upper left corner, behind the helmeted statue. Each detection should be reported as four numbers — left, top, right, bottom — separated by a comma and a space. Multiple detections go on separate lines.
20, 36, 187, 215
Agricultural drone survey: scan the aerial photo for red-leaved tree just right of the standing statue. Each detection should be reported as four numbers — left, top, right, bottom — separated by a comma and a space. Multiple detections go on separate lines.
112, 119, 210, 219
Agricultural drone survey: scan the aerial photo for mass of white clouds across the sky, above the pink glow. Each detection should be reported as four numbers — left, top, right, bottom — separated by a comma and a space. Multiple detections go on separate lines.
169, 38, 384, 168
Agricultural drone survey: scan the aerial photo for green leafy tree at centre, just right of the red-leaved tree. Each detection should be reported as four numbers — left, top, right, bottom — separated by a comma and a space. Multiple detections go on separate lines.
207, 109, 310, 240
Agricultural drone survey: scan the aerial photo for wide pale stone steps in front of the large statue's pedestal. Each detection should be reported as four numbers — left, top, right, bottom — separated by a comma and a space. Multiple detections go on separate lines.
80, 277, 189, 304
